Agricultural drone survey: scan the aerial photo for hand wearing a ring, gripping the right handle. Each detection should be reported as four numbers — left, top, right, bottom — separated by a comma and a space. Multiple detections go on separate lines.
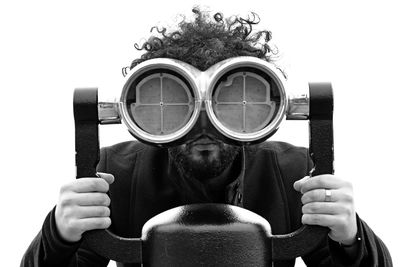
293, 174, 357, 245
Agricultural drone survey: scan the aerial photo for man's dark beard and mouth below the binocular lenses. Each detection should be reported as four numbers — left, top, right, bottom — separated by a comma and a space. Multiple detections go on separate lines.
168, 135, 240, 181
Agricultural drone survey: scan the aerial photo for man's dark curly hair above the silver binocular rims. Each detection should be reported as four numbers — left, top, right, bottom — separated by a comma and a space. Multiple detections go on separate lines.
122, 8, 277, 76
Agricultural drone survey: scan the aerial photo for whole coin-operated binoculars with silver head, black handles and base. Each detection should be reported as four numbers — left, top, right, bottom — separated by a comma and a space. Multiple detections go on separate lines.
74, 57, 333, 266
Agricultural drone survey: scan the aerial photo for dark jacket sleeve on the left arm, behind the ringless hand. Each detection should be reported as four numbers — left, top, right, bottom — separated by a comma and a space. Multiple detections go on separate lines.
20, 151, 109, 267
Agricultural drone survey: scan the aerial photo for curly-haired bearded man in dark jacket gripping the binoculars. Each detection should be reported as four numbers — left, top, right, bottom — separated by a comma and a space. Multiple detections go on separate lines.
21, 9, 392, 266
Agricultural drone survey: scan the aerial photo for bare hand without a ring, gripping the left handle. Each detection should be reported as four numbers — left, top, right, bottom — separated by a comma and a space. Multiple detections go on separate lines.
55, 173, 114, 242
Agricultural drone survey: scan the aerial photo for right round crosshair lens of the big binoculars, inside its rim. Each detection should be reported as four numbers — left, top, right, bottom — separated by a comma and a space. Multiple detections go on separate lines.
212, 70, 281, 133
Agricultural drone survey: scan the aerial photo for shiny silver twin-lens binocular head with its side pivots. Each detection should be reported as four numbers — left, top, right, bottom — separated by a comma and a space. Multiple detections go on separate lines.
99, 57, 309, 145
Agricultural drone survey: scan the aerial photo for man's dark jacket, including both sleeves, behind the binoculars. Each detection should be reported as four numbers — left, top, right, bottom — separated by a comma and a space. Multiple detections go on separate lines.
21, 142, 392, 267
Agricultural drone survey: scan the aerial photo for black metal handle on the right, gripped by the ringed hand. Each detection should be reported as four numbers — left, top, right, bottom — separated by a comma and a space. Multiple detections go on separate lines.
272, 83, 334, 260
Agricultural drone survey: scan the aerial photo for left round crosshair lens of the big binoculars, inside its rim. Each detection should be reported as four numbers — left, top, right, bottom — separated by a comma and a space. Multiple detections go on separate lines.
127, 72, 194, 135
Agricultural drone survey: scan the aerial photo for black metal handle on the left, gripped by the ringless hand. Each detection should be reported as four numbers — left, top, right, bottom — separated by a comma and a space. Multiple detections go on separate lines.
74, 88, 142, 263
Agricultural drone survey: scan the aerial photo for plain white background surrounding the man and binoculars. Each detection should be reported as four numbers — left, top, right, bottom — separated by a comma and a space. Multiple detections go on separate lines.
0, 0, 400, 266
